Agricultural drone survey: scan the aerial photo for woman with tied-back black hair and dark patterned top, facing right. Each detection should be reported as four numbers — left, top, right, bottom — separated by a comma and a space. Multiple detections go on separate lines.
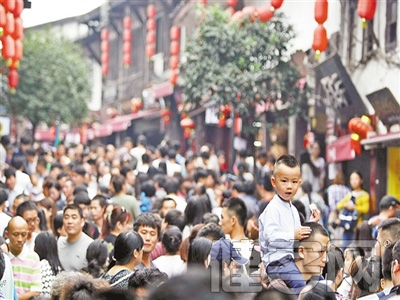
101, 231, 143, 289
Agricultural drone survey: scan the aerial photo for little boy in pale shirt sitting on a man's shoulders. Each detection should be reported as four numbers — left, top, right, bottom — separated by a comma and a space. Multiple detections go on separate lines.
259, 155, 320, 290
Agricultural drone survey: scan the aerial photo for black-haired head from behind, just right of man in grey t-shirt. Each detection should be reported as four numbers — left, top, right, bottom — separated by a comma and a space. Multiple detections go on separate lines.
82, 240, 108, 278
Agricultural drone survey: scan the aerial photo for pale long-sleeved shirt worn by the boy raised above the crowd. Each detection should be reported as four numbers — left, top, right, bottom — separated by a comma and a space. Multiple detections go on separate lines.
258, 195, 301, 266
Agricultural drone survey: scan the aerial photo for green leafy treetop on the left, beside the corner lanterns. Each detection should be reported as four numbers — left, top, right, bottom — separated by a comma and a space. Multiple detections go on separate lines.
0, 29, 91, 127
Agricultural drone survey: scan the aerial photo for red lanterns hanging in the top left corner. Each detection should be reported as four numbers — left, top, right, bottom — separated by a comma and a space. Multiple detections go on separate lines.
0, 0, 24, 92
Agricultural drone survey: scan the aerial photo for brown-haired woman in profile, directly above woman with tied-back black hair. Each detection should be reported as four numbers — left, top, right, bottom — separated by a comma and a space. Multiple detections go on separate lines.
100, 205, 133, 258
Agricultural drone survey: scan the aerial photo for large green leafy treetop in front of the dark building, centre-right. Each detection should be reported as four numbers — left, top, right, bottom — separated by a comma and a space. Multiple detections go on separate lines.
180, 6, 307, 134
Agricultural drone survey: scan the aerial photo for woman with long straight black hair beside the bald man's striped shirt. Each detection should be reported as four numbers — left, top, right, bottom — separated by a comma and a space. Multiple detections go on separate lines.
35, 231, 63, 297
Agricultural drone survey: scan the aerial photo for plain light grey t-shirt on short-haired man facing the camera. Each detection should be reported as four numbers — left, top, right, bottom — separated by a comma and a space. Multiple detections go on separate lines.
57, 232, 93, 271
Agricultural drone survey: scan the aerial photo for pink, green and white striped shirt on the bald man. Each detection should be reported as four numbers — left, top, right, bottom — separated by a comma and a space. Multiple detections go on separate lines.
8, 246, 42, 295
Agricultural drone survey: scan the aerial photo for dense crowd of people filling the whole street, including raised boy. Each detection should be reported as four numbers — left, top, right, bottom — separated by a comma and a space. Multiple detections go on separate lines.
0, 135, 400, 300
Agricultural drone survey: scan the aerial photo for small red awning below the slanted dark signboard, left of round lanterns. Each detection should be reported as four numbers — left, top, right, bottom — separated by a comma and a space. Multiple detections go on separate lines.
326, 135, 356, 163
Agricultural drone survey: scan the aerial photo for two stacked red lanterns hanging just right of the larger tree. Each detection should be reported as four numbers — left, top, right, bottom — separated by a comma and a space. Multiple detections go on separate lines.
312, 0, 329, 60
